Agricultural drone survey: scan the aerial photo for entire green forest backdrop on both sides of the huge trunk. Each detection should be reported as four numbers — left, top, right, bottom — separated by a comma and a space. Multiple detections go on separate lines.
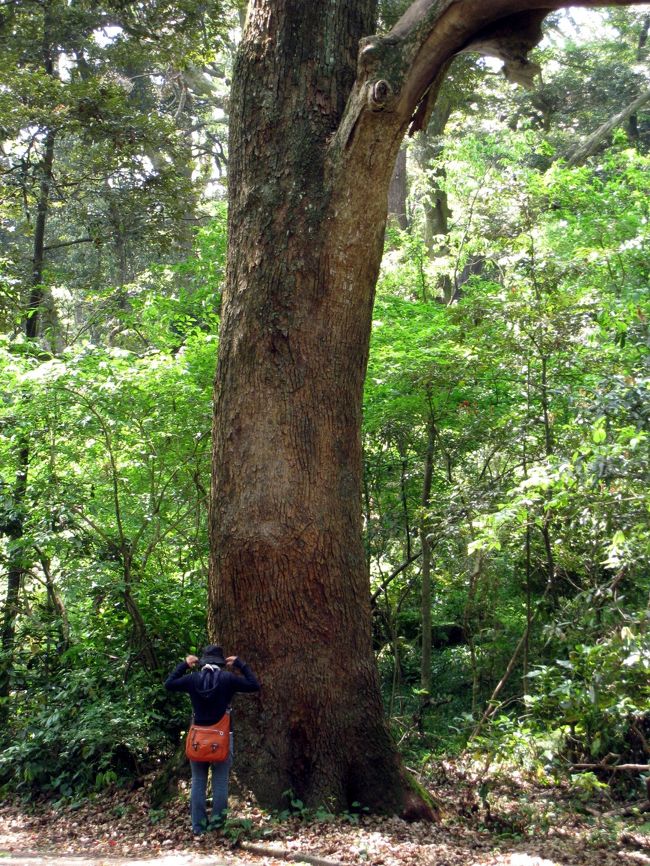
0, 0, 650, 798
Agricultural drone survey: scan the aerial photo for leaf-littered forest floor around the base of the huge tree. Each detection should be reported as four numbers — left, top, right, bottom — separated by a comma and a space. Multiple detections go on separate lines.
0, 762, 650, 866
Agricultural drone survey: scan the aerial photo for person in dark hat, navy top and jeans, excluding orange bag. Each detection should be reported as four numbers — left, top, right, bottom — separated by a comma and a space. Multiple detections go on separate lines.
165, 644, 260, 836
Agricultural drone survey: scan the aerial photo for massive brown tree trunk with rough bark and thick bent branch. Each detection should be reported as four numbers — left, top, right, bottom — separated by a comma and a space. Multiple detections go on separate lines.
209, 0, 644, 815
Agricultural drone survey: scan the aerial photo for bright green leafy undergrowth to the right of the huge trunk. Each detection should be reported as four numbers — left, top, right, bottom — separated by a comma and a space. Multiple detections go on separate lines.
364, 12, 650, 784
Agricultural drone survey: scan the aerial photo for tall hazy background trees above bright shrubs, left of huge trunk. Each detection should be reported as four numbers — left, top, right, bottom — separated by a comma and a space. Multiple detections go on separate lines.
0, 0, 229, 344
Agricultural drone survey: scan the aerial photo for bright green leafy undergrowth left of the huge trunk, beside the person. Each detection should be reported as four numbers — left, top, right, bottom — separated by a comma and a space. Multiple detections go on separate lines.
0, 208, 225, 796
